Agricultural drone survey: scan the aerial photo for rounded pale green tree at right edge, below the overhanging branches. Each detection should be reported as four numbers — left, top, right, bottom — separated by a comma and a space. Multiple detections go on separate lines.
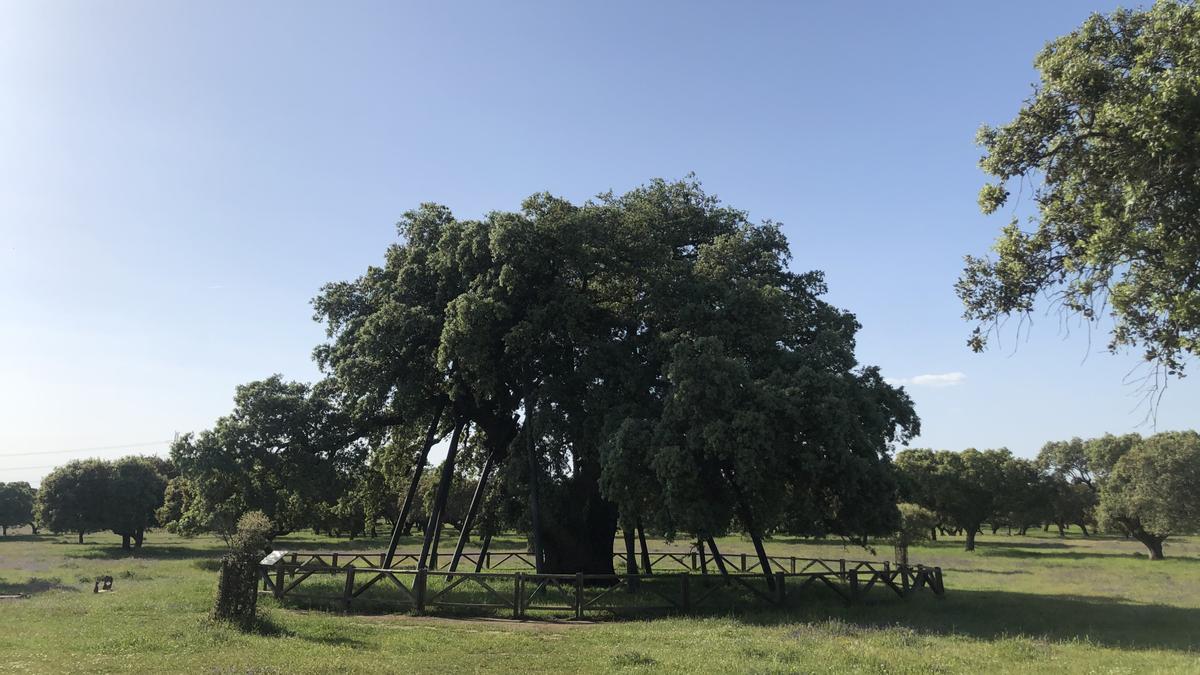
1099, 431, 1200, 560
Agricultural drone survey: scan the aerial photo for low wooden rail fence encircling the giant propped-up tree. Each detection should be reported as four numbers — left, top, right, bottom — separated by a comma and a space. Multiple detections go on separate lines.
260, 551, 946, 619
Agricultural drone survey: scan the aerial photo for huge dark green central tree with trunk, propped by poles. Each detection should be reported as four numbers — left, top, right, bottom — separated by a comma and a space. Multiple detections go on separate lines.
314, 176, 918, 572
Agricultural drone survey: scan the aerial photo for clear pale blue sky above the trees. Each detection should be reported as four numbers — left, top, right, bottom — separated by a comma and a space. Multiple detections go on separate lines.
0, 0, 1200, 483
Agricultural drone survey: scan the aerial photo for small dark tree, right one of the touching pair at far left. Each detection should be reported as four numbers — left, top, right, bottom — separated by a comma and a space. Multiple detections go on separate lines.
106, 456, 167, 549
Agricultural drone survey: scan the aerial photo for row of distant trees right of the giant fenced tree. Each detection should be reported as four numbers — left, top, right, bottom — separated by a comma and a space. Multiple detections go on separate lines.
895, 431, 1200, 560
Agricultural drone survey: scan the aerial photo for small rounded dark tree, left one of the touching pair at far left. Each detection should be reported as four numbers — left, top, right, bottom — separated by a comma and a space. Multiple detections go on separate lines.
37, 459, 113, 544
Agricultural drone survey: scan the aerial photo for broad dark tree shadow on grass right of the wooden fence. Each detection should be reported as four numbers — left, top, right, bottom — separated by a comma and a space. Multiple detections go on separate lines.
742, 589, 1200, 652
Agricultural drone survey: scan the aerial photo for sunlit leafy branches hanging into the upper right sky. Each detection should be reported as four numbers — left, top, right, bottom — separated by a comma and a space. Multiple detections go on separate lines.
958, 0, 1200, 382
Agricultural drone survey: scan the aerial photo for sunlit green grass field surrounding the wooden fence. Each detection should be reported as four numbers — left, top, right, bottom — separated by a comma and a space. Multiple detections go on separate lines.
0, 532, 1200, 674
